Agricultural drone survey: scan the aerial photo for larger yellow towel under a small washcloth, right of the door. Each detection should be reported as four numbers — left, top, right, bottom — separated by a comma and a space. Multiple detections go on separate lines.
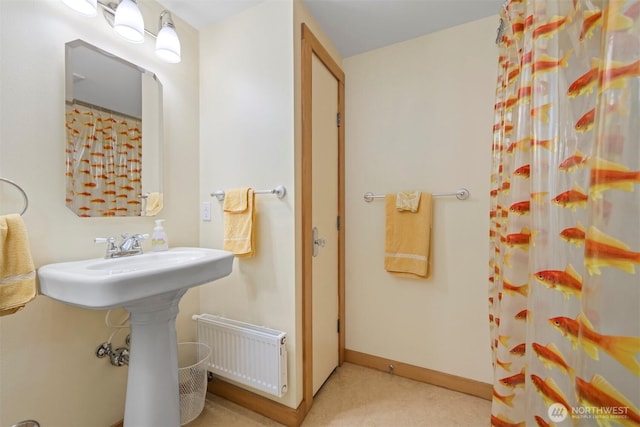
384, 193, 431, 279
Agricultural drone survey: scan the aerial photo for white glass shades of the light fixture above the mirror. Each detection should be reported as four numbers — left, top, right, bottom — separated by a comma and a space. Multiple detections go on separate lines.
62, 0, 180, 64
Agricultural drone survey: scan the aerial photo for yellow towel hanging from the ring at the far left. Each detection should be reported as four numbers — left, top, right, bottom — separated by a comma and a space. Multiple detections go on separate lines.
0, 214, 37, 316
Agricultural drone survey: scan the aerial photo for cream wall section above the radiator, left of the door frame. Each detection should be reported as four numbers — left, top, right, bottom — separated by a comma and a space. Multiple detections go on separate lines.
200, 0, 301, 408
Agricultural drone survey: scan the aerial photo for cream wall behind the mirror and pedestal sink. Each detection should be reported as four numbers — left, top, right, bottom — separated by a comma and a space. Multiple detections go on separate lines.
0, 0, 199, 427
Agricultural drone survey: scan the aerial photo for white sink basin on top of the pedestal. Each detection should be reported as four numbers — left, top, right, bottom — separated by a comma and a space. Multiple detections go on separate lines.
38, 248, 233, 309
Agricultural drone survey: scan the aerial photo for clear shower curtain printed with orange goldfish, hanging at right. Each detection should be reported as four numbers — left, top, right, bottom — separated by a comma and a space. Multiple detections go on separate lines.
489, 0, 640, 427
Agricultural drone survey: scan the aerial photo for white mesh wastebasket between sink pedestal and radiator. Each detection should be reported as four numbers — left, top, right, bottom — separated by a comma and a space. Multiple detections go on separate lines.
178, 342, 211, 425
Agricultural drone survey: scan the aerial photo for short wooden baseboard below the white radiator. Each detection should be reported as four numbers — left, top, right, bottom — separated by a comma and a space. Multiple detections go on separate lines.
207, 377, 306, 427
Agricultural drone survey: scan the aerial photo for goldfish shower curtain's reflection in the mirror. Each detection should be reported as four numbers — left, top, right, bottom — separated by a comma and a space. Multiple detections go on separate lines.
65, 104, 142, 217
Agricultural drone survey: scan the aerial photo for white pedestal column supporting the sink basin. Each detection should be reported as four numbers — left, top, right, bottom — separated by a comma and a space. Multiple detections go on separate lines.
124, 289, 186, 427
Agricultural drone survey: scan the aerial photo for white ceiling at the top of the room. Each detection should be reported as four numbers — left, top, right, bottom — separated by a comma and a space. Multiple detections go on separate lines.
159, 0, 504, 58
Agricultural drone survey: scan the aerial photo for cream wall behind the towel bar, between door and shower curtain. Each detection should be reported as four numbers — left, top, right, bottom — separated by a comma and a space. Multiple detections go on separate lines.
343, 17, 498, 382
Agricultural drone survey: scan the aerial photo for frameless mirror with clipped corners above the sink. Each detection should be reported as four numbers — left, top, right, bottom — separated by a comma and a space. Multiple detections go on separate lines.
65, 40, 163, 217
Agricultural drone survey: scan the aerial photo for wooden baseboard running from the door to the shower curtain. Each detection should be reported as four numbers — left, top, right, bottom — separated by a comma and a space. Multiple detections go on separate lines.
344, 349, 493, 400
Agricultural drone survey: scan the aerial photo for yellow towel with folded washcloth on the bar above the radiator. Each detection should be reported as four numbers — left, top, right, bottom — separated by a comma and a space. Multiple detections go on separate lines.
222, 188, 256, 258
